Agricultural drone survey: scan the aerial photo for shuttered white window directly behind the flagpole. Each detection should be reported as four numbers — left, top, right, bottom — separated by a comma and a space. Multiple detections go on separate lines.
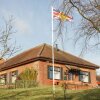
48, 66, 62, 79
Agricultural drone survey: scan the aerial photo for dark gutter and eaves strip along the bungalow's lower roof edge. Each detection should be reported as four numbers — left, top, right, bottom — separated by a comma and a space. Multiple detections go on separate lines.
0, 57, 100, 72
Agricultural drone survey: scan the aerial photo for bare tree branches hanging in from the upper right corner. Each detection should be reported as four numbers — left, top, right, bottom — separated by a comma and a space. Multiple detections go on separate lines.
53, 0, 100, 53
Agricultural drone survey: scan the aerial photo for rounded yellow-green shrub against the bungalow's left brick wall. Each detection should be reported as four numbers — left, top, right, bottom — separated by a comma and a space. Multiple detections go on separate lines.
15, 68, 38, 88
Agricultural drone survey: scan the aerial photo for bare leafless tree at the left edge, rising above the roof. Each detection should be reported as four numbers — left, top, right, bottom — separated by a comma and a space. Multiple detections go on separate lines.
0, 16, 19, 59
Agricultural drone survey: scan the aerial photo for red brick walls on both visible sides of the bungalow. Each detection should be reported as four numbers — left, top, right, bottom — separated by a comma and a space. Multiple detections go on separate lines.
0, 61, 97, 87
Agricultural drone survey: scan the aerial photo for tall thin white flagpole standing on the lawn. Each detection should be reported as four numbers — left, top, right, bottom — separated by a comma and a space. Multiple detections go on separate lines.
51, 7, 55, 94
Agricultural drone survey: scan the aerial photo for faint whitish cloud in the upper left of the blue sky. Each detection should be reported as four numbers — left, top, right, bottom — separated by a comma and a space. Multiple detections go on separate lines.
0, 9, 31, 34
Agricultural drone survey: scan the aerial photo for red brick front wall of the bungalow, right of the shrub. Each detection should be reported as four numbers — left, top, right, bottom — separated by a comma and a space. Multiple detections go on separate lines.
39, 61, 97, 87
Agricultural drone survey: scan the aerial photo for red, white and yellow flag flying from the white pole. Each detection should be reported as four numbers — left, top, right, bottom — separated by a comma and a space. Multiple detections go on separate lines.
53, 9, 73, 21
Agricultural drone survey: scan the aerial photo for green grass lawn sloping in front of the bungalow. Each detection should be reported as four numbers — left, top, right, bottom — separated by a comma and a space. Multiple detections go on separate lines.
0, 87, 100, 100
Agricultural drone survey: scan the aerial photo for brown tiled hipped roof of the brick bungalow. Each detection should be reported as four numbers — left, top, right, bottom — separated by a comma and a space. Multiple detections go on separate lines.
0, 44, 99, 71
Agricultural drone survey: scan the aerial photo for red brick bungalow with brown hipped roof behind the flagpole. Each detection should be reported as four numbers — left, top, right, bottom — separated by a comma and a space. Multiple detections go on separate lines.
0, 44, 99, 87
